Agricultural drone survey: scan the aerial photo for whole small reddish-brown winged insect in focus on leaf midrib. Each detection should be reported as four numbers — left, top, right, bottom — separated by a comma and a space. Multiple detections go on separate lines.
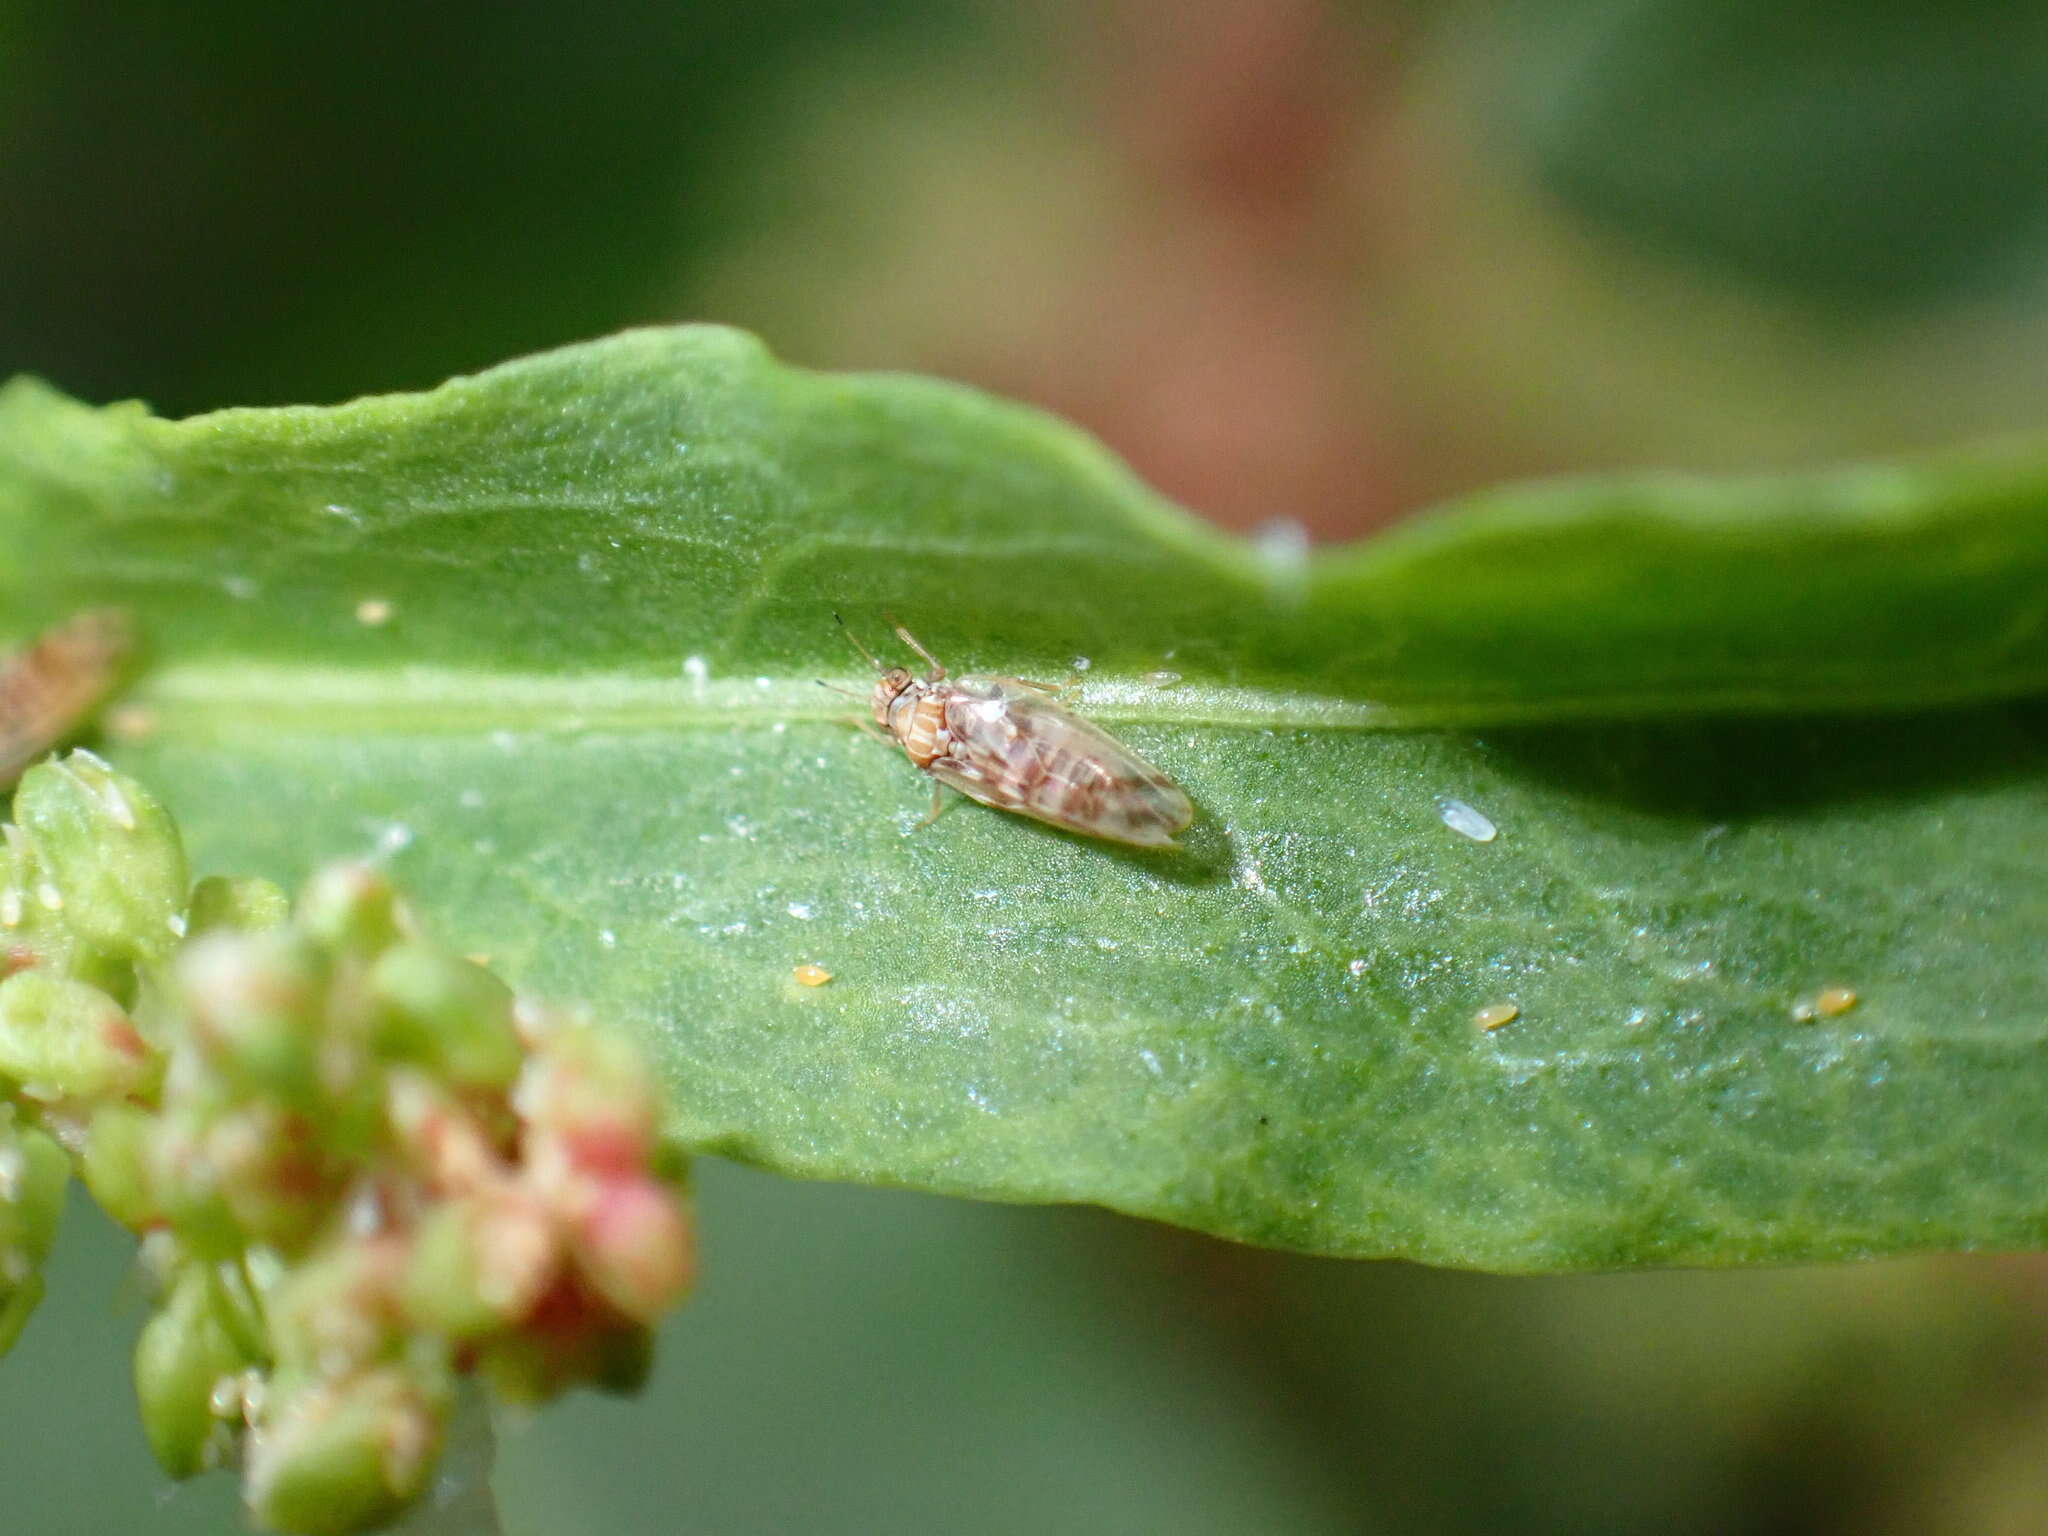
827, 614, 1194, 848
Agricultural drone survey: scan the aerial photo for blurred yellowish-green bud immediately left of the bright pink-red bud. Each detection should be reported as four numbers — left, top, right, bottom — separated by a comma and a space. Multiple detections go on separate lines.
406, 1182, 561, 1339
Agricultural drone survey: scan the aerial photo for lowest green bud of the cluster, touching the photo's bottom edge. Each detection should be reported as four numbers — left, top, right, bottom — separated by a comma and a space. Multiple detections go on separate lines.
246, 1366, 449, 1536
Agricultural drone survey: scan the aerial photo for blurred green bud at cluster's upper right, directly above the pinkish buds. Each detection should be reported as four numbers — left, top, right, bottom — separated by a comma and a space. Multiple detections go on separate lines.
369, 940, 524, 1092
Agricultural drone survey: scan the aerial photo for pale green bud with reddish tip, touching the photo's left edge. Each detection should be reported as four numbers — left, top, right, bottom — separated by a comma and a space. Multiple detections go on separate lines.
0, 971, 162, 1104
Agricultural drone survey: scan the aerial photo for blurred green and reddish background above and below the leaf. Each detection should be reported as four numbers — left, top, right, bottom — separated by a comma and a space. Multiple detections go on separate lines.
0, 0, 2048, 1536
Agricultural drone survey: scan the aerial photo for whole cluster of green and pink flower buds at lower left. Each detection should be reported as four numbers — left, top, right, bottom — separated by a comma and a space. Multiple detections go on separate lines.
0, 754, 692, 1532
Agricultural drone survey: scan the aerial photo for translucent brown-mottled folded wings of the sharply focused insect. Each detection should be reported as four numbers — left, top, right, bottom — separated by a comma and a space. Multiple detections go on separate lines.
930, 678, 1194, 848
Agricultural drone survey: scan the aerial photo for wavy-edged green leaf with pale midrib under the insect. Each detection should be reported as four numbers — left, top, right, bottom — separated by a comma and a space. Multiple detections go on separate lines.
0, 330, 2048, 1270
